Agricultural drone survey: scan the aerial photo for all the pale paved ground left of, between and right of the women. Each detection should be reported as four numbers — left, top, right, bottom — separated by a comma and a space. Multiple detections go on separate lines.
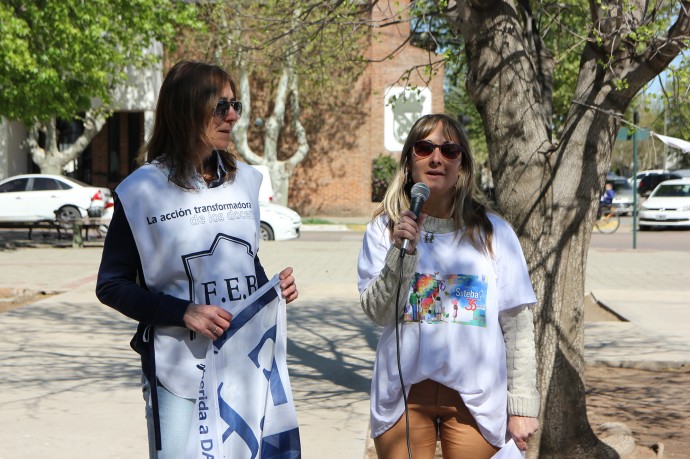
0, 231, 690, 459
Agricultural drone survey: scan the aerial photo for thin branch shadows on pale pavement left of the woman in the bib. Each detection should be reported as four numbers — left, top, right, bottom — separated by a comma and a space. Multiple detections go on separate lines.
0, 301, 141, 408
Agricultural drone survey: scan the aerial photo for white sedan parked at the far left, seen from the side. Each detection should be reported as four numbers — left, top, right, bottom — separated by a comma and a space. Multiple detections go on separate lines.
0, 174, 111, 224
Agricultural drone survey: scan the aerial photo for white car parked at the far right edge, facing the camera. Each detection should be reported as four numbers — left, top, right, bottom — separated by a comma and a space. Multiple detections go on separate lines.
638, 178, 690, 231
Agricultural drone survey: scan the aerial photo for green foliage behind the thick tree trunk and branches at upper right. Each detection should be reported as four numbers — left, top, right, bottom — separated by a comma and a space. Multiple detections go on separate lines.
411, 0, 690, 146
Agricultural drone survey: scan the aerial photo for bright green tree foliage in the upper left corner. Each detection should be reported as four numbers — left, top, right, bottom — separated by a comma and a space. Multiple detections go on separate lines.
0, 0, 196, 124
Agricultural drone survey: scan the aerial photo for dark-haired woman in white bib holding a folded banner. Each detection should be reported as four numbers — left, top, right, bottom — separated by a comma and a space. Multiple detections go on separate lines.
96, 61, 298, 459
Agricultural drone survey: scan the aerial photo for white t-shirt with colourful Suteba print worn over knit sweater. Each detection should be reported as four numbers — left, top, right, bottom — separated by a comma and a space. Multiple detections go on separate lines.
358, 214, 536, 447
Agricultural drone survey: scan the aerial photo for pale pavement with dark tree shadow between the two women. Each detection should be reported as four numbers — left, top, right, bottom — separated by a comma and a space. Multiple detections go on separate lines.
259, 232, 379, 459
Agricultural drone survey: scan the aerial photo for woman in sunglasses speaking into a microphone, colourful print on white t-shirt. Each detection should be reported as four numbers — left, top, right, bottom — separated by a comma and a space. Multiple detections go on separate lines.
358, 114, 540, 459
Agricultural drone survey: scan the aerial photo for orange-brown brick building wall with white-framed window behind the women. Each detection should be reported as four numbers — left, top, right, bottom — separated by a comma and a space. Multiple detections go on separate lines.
288, 2, 444, 217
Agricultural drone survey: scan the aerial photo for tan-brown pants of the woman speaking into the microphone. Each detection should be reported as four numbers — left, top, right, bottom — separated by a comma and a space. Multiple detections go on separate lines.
374, 379, 498, 459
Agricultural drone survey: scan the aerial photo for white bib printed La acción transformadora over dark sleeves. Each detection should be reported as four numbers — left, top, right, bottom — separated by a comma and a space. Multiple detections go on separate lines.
116, 162, 261, 398
